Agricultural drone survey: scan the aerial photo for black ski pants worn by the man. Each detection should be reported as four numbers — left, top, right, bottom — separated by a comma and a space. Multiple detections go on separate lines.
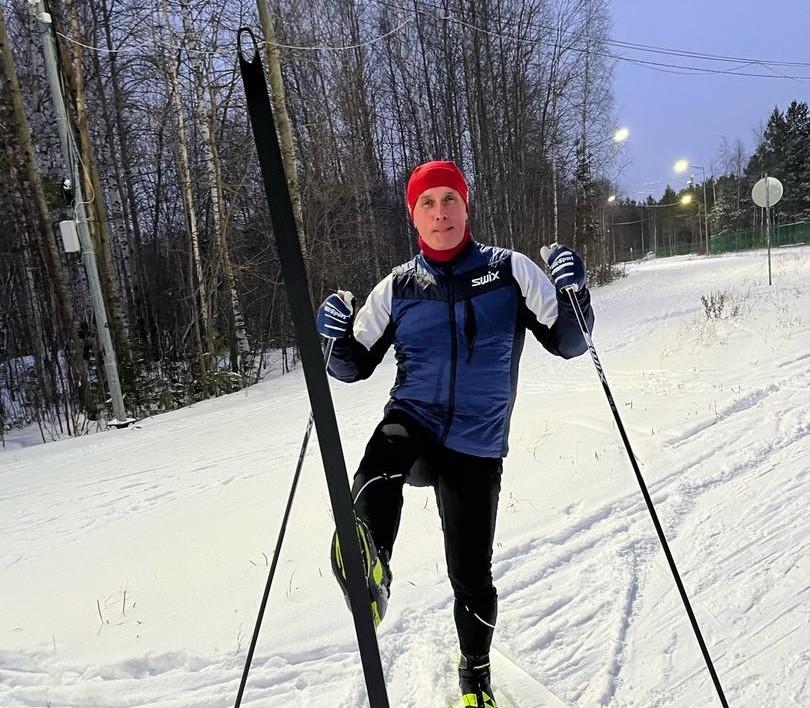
352, 411, 502, 656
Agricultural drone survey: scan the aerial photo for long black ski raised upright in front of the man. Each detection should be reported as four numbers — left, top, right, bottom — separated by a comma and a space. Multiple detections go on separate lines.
237, 28, 389, 708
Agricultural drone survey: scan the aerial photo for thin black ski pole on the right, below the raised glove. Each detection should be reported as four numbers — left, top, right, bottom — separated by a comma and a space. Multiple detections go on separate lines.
565, 287, 728, 708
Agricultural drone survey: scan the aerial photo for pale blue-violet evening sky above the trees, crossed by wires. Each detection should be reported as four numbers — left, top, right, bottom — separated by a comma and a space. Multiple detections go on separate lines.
608, 0, 810, 199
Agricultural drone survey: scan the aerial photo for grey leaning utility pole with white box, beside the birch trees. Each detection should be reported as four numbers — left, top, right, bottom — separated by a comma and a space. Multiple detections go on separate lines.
28, 0, 129, 426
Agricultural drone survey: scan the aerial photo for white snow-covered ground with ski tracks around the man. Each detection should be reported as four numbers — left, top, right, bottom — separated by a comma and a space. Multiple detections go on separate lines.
0, 247, 810, 708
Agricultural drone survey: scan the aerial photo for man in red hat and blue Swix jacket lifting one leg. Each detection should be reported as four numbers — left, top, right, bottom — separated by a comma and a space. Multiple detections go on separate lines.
317, 161, 593, 708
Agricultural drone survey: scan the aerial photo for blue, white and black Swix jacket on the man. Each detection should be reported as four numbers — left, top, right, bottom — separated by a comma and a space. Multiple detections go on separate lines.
329, 241, 593, 457
